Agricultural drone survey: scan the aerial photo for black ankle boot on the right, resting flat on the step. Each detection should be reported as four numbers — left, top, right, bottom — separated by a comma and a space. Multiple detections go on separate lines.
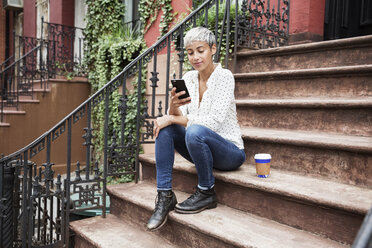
175, 188, 217, 214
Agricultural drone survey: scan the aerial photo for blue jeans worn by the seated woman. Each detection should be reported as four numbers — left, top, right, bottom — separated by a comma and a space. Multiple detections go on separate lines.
155, 125, 245, 190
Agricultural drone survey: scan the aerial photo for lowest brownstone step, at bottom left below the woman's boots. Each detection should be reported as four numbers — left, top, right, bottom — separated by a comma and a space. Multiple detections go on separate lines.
70, 214, 179, 248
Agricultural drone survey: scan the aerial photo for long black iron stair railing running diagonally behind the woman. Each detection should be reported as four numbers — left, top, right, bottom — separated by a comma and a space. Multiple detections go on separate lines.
0, 0, 289, 247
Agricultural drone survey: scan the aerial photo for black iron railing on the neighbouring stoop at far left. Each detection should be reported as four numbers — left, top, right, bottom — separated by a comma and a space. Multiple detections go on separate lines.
0, 18, 85, 122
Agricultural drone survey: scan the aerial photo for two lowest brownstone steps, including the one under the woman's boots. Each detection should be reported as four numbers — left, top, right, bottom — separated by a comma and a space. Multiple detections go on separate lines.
71, 182, 352, 248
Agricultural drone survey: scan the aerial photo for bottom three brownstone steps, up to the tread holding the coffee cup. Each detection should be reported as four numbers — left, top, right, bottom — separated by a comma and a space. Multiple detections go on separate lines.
71, 152, 372, 248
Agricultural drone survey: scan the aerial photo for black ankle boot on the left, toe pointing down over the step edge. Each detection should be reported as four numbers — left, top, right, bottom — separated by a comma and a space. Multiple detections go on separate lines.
147, 190, 177, 231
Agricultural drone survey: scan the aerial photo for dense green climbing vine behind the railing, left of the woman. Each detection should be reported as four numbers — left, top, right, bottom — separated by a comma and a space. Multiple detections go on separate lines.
84, 0, 146, 161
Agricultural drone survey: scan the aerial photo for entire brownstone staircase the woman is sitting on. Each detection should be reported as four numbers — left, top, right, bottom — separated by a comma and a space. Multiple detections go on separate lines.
71, 36, 372, 248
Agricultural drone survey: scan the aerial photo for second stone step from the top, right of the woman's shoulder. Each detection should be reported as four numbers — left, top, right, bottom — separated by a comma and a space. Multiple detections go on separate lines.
234, 64, 372, 98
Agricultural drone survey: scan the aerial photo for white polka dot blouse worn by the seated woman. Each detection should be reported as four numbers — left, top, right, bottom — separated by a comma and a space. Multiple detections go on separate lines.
180, 64, 244, 149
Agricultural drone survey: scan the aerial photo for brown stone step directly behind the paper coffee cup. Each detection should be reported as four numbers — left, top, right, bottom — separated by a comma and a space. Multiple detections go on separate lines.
241, 127, 372, 188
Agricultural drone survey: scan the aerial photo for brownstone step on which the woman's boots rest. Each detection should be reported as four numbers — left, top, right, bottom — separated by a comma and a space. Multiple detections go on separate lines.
108, 182, 345, 248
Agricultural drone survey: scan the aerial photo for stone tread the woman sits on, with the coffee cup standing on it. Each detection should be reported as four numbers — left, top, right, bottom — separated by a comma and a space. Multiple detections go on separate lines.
140, 154, 372, 215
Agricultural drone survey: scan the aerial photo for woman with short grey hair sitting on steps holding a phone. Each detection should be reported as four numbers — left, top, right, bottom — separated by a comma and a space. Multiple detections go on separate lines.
147, 27, 245, 230
